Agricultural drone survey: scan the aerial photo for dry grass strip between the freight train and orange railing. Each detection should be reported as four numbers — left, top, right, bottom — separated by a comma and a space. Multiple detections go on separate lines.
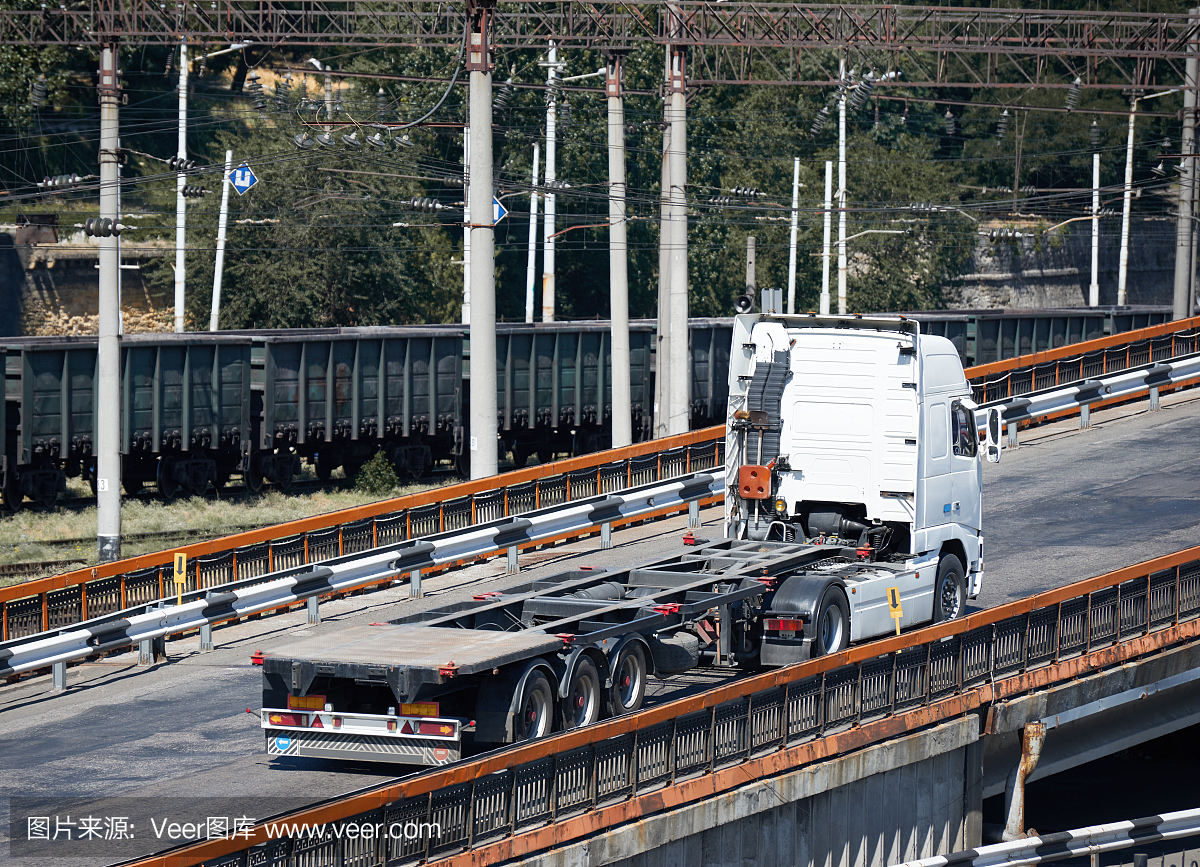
0, 467, 440, 587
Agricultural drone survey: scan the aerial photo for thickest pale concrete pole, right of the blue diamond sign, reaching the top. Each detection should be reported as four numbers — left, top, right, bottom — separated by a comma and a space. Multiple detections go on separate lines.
467, 0, 498, 479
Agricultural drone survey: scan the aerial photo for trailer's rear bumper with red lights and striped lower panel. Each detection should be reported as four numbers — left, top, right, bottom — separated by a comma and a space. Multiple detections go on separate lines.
262, 707, 462, 766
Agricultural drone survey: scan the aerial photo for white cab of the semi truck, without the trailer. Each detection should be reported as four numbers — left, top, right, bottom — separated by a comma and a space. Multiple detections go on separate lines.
725, 313, 1000, 640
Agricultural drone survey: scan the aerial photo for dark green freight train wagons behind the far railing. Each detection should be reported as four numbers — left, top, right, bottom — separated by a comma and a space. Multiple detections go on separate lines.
0, 307, 1170, 509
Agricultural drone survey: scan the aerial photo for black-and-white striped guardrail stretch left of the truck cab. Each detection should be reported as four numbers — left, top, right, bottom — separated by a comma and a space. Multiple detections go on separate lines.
0, 472, 725, 677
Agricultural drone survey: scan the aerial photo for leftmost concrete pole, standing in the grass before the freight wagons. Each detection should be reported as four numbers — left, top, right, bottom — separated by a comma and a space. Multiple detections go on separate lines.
96, 46, 121, 563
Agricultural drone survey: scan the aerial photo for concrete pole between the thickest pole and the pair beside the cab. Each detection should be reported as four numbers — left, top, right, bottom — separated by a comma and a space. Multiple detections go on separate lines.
601, 52, 634, 448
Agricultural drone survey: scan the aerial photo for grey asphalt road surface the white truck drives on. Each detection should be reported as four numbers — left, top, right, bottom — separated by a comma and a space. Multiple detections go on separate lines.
0, 393, 1200, 867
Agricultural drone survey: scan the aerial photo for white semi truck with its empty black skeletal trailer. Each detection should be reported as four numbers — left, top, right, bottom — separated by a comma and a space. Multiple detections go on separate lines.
262, 315, 1000, 765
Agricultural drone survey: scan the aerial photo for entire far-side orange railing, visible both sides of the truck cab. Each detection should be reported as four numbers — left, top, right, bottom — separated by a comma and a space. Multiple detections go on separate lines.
7, 317, 1200, 641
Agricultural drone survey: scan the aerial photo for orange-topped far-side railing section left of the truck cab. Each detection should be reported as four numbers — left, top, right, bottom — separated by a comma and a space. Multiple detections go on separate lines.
0, 427, 725, 641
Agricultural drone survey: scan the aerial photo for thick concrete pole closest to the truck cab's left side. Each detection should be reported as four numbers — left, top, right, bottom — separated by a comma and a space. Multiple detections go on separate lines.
667, 4, 691, 434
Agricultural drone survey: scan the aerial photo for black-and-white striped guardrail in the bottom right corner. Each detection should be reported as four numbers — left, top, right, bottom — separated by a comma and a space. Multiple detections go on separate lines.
898, 809, 1200, 867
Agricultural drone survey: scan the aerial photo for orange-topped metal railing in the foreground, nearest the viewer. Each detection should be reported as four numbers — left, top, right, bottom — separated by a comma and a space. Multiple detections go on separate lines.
114, 548, 1200, 867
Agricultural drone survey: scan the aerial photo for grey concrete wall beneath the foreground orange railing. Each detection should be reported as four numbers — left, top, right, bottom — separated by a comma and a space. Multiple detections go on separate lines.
520, 716, 983, 867
